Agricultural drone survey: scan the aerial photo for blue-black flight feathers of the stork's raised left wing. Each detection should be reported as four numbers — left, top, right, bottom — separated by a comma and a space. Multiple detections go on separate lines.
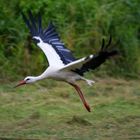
22, 11, 76, 64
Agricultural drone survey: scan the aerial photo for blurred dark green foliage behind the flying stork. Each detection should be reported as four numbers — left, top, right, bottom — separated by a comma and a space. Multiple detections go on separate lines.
0, 0, 140, 80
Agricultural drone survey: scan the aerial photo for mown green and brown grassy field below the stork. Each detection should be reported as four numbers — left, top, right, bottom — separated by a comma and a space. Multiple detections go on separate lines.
0, 78, 140, 140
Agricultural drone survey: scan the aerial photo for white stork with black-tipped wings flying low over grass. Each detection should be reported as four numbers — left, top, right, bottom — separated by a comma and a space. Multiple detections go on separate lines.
16, 11, 117, 112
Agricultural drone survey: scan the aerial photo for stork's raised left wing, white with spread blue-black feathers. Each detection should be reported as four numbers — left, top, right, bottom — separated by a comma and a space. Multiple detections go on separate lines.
22, 11, 76, 67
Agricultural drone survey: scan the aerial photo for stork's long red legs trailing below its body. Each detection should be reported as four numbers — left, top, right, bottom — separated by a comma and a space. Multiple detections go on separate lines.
69, 83, 90, 112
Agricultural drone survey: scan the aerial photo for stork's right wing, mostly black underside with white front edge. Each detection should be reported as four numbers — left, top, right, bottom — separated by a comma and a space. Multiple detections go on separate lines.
62, 37, 118, 75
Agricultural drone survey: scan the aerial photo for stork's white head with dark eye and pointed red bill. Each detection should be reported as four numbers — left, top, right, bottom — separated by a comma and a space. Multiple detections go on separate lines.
15, 76, 36, 87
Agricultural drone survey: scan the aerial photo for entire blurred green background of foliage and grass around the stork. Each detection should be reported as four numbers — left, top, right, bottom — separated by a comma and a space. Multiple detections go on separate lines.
0, 0, 140, 140
